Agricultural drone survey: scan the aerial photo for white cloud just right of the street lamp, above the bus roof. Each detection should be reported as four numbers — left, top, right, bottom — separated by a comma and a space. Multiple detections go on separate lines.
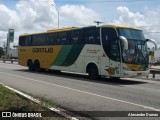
60, 5, 101, 25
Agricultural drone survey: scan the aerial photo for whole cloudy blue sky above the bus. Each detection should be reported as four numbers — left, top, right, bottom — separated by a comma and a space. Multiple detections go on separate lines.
0, 0, 160, 47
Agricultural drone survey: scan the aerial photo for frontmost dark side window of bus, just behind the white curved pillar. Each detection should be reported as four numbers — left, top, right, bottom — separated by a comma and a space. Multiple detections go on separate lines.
85, 28, 100, 44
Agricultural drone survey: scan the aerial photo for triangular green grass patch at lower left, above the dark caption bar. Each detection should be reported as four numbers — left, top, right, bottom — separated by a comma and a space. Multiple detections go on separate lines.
0, 85, 44, 112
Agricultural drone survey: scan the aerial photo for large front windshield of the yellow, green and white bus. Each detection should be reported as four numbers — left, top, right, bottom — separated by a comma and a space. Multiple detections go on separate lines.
118, 28, 149, 64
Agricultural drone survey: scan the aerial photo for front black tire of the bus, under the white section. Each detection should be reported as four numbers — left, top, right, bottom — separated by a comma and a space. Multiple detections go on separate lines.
87, 64, 99, 80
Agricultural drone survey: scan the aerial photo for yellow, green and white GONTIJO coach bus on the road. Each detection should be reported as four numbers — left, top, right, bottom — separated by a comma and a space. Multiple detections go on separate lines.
18, 24, 156, 79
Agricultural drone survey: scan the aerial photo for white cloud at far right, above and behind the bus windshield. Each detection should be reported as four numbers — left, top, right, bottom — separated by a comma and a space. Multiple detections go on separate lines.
114, 6, 160, 47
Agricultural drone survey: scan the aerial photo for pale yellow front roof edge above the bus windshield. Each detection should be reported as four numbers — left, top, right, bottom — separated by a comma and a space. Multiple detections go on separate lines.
102, 24, 141, 30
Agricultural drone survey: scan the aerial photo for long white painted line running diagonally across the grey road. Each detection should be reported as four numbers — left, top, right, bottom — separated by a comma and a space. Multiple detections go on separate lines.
0, 72, 160, 111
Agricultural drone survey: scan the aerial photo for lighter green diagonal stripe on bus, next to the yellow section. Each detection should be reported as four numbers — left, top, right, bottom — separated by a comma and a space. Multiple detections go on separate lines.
52, 45, 72, 66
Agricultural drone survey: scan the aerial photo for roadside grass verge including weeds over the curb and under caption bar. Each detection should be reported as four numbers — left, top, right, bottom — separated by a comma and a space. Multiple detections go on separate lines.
0, 84, 67, 120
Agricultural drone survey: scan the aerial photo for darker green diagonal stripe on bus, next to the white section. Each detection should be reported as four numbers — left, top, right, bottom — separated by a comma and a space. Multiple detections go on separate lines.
61, 45, 84, 66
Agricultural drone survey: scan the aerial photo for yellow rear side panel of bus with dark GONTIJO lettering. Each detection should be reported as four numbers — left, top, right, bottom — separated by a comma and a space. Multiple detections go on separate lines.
18, 45, 62, 68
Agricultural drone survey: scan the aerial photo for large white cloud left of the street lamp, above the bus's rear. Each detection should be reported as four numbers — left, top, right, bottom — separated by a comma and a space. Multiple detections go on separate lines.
0, 0, 56, 46
